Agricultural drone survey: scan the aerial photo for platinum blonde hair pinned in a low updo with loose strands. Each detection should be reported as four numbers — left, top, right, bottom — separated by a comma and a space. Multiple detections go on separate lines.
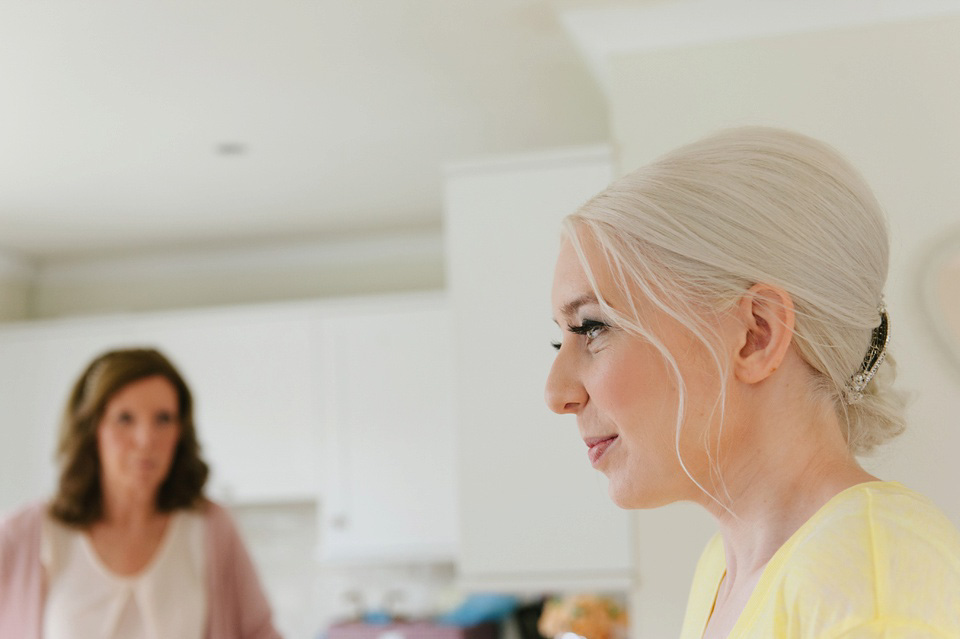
564, 127, 905, 484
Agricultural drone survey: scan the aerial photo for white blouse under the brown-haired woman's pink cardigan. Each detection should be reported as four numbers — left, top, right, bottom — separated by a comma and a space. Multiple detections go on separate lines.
41, 511, 207, 639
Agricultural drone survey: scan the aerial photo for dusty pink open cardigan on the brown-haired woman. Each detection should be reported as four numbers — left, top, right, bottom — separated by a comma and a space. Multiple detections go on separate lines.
0, 502, 280, 639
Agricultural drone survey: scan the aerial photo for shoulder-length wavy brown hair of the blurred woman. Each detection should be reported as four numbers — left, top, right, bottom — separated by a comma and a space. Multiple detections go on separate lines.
50, 348, 209, 528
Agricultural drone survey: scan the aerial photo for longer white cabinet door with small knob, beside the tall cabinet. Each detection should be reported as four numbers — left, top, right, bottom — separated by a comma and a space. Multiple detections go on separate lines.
320, 295, 457, 563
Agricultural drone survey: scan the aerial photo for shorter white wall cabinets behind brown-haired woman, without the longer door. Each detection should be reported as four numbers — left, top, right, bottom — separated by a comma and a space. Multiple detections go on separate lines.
0, 307, 320, 511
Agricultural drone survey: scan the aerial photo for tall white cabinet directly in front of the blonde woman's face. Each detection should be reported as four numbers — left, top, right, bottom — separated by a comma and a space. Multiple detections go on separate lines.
444, 149, 633, 590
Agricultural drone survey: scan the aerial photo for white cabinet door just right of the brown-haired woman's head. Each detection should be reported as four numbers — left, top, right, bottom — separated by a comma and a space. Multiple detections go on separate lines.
129, 305, 320, 503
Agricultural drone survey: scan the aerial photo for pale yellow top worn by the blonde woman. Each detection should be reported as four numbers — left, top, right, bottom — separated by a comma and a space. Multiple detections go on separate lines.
680, 481, 960, 639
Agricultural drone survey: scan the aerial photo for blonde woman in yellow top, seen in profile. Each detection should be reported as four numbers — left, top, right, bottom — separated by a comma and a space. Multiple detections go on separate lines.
546, 128, 960, 639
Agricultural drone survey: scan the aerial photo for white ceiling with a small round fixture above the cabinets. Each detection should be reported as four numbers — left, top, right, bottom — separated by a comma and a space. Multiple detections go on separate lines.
0, 0, 608, 261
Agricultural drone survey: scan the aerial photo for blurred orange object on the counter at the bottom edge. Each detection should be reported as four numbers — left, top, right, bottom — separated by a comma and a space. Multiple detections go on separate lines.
537, 595, 627, 639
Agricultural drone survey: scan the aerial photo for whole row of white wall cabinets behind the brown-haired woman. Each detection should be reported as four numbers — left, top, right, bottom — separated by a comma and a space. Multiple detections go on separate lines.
0, 294, 457, 563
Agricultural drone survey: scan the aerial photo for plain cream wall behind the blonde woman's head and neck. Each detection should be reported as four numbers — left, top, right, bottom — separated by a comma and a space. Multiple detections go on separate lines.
609, 13, 960, 637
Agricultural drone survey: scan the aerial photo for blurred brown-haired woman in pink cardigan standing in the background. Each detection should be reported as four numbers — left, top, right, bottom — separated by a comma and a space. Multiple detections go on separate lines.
0, 349, 279, 639
